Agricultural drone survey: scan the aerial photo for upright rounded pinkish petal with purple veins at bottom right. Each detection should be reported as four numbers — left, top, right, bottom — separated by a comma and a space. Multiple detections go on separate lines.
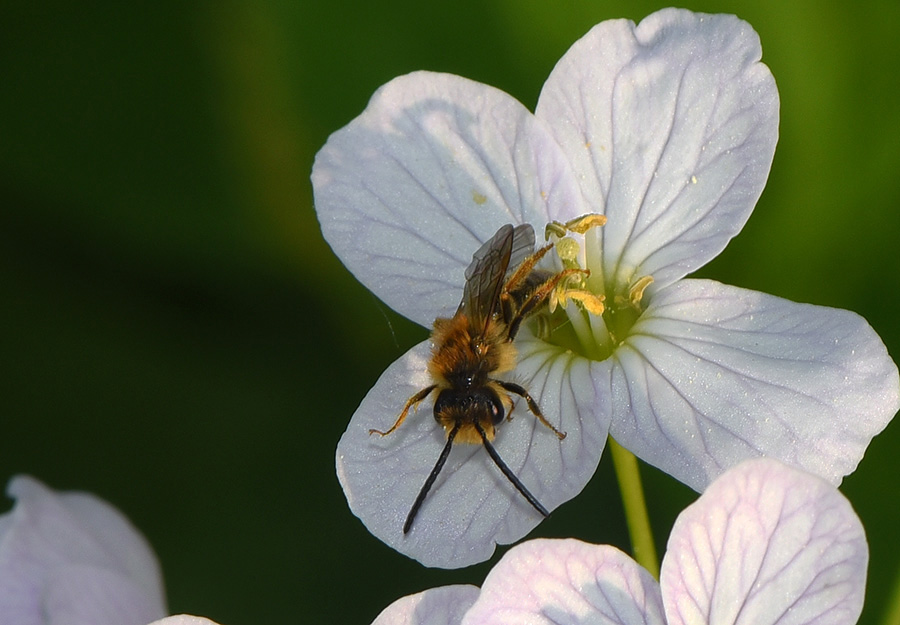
660, 459, 869, 625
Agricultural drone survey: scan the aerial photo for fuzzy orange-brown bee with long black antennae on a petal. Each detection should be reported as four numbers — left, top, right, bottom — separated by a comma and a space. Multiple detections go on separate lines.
369, 224, 589, 534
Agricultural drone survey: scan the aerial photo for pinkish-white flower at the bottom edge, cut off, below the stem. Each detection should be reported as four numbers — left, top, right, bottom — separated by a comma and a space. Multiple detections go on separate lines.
375, 459, 869, 625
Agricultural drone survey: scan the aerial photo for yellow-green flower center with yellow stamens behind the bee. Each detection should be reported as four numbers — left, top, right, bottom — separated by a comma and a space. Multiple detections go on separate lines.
538, 214, 653, 360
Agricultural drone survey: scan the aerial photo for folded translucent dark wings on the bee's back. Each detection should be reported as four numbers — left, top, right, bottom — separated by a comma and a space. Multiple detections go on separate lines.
459, 224, 534, 331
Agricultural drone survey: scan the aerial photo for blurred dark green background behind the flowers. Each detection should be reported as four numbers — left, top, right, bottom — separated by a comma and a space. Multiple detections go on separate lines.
0, 0, 900, 625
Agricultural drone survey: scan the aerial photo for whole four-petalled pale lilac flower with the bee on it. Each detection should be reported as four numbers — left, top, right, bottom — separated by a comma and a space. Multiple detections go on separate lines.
312, 9, 900, 567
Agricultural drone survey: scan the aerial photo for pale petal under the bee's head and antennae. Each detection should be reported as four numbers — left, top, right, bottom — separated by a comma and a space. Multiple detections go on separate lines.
336, 331, 609, 568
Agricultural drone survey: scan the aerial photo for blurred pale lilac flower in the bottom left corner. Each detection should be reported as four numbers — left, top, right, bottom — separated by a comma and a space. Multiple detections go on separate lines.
0, 476, 165, 625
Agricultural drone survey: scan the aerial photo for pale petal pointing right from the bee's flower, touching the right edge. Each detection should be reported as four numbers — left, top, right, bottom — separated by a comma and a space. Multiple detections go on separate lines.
610, 280, 900, 490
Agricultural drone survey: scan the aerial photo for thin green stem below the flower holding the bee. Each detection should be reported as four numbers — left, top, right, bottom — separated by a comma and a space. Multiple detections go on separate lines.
607, 437, 659, 579
